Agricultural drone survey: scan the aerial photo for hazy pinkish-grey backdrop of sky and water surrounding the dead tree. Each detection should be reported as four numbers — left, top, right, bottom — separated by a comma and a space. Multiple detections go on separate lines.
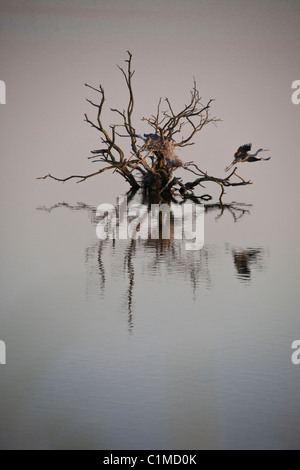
0, 0, 300, 448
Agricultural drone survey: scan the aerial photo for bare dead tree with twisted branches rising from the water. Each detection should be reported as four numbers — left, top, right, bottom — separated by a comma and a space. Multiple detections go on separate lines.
37, 51, 251, 203
